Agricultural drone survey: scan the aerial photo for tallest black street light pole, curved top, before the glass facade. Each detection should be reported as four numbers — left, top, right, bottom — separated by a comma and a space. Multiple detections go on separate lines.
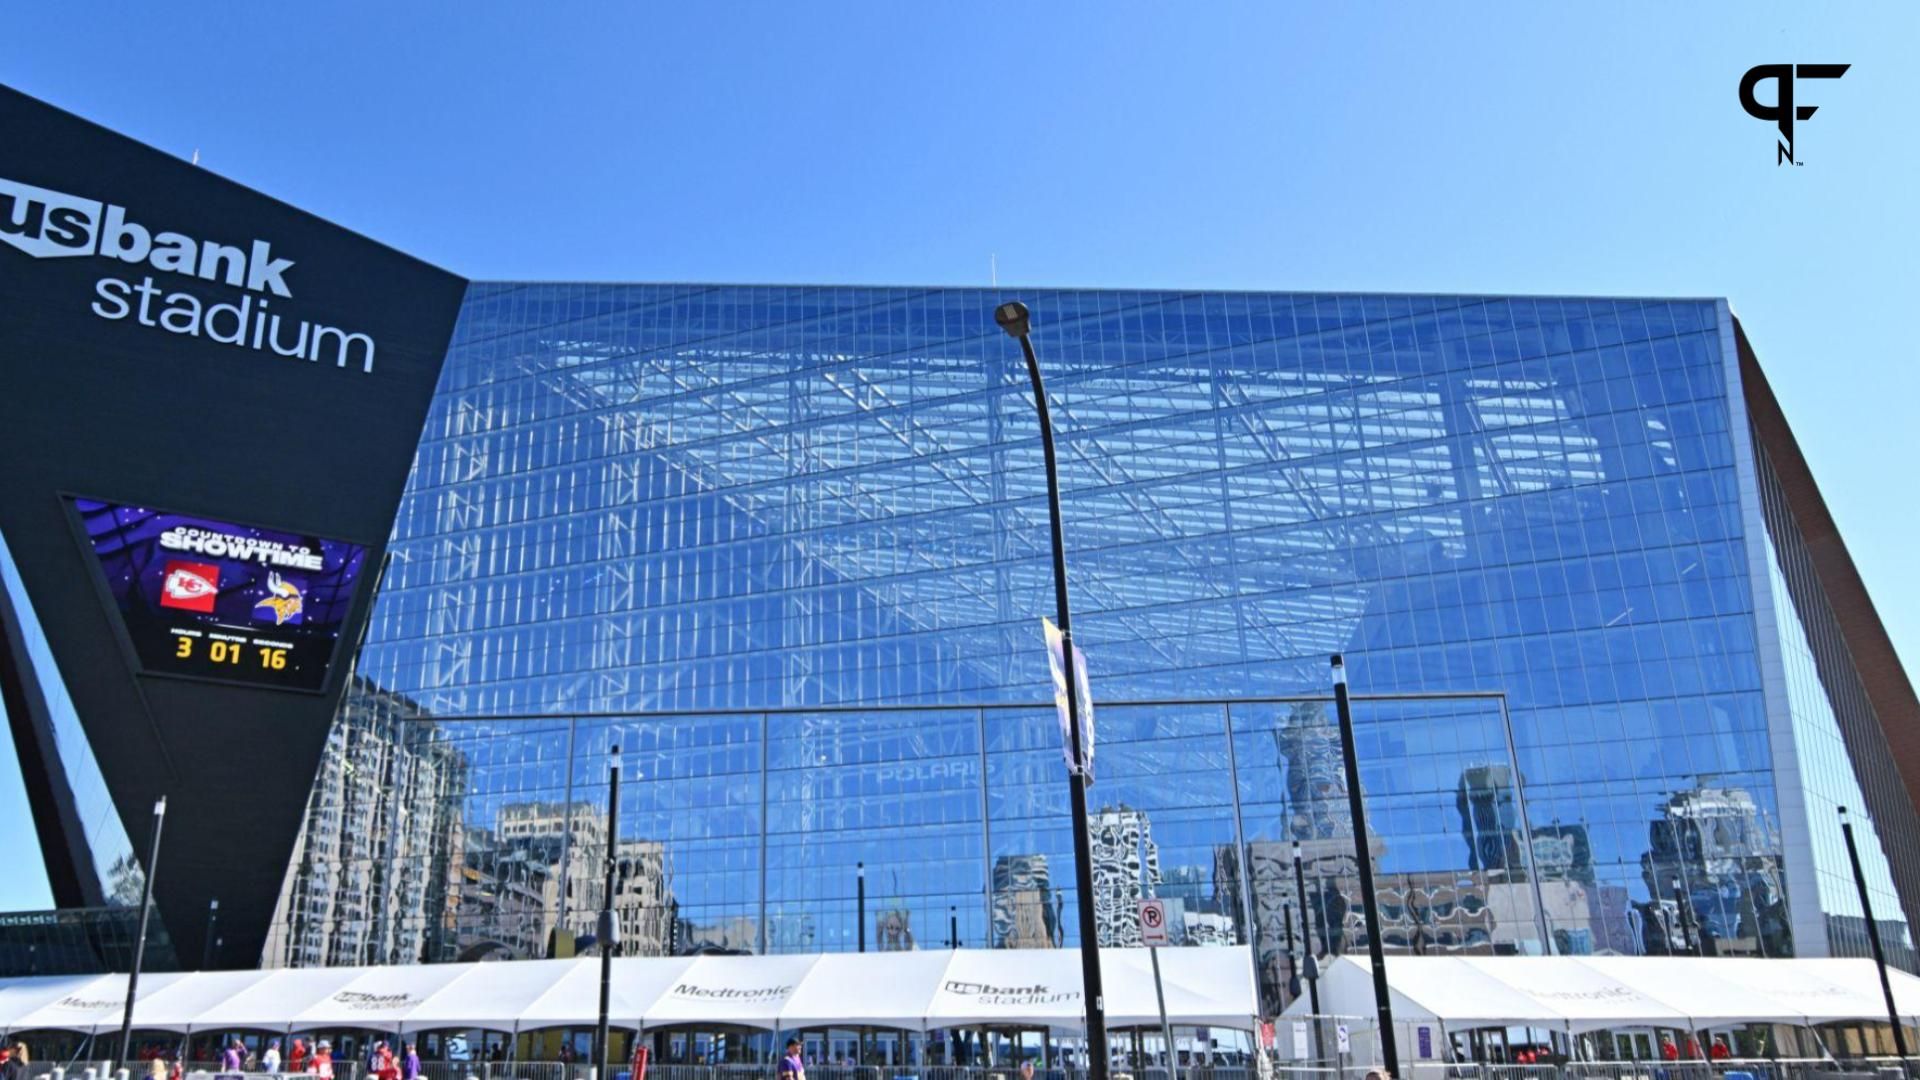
993, 300, 1108, 1080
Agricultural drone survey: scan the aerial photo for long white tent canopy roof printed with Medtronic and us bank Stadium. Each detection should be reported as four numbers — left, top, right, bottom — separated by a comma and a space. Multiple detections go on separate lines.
0, 945, 1258, 1032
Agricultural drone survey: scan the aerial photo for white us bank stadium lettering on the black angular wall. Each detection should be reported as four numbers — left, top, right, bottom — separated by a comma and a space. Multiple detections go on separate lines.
0, 177, 376, 375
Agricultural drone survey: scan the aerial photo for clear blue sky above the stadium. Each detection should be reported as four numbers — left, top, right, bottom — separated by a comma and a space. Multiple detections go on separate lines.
0, 2, 1920, 909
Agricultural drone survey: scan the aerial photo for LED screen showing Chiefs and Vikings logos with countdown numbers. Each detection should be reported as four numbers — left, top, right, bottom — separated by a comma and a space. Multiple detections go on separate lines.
67, 498, 367, 692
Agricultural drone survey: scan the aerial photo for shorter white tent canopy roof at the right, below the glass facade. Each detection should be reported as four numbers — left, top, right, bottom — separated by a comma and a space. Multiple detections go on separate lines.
1286, 957, 1920, 1032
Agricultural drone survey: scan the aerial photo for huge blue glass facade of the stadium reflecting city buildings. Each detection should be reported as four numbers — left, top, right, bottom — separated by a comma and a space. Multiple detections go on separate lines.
267, 282, 1920, 992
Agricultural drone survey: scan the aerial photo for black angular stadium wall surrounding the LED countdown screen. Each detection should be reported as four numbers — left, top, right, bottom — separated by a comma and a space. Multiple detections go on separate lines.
0, 79, 467, 963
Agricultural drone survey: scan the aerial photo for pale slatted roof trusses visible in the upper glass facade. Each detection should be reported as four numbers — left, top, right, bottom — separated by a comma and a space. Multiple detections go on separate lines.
412, 286, 1601, 691
